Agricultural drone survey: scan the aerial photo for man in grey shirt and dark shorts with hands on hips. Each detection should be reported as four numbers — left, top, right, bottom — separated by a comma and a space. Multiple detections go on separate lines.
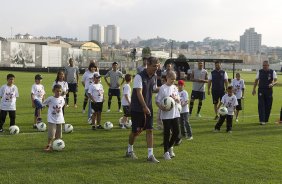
104, 62, 124, 112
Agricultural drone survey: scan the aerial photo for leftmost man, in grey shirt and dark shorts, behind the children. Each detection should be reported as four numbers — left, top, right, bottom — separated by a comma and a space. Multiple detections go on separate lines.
65, 58, 79, 108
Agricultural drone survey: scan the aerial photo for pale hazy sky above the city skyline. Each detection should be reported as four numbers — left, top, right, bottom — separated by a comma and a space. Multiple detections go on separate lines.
0, 0, 282, 47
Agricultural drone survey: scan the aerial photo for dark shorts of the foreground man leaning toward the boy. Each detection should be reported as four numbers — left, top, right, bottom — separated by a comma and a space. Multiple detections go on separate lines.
131, 111, 153, 133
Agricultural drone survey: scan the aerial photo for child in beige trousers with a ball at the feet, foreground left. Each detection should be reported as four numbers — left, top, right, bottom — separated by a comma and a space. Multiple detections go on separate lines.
43, 84, 65, 151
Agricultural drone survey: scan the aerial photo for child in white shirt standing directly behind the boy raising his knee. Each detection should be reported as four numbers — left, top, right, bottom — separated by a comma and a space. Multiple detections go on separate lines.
231, 73, 245, 122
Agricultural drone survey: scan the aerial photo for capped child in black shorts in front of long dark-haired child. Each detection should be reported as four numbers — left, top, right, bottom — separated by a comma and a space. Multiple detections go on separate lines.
88, 73, 104, 130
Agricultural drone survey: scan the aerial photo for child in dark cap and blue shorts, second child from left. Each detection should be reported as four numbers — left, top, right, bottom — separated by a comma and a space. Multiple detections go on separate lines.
31, 74, 45, 129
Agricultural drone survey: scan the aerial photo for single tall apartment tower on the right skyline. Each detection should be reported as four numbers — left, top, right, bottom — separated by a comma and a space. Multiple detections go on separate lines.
240, 28, 261, 54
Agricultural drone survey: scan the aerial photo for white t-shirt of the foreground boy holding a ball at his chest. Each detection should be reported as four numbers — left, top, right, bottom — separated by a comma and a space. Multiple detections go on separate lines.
156, 84, 180, 119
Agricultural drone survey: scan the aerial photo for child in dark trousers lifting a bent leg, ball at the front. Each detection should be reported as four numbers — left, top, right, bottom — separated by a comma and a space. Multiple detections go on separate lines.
214, 86, 238, 133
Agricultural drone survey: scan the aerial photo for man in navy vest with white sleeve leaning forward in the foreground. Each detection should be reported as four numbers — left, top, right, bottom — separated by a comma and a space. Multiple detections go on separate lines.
126, 57, 159, 163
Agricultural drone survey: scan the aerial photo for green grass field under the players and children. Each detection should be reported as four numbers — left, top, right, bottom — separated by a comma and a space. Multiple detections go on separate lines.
0, 71, 282, 184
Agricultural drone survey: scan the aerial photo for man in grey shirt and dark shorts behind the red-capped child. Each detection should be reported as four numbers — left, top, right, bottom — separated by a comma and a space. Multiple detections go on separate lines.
189, 61, 208, 117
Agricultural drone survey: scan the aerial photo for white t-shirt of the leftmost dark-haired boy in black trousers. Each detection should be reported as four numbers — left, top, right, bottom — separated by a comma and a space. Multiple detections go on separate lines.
0, 84, 19, 111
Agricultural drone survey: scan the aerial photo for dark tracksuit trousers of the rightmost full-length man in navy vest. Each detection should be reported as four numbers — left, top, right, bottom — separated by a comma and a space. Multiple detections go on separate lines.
258, 88, 273, 122
